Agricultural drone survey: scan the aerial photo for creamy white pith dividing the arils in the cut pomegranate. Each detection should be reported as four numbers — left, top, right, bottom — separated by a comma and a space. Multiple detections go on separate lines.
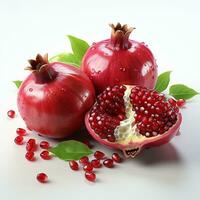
114, 85, 152, 144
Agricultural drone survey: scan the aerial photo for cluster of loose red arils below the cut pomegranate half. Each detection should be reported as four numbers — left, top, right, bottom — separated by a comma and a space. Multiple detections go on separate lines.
69, 151, 122, 182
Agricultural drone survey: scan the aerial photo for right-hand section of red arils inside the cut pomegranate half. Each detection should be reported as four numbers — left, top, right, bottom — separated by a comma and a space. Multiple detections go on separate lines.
130, 87, 179, 137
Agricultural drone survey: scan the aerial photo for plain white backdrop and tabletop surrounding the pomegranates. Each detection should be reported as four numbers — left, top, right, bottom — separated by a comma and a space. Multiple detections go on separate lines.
0, 0, 200, 200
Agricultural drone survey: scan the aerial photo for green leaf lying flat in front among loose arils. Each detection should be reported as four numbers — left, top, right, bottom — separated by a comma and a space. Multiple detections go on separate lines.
49, 140, 93, 160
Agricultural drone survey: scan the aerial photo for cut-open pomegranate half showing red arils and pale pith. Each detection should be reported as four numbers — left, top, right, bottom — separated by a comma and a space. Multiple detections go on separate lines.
85, 85, 182, 157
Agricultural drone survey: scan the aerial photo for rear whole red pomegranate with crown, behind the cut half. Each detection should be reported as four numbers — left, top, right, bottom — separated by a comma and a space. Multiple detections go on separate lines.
81, 23, 157, 93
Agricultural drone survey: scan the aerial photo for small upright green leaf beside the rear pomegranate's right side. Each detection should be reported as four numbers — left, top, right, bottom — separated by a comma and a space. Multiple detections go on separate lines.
155, 71, 171, 93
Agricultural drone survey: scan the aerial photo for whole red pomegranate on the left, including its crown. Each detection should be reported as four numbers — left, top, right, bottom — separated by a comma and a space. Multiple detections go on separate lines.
17, 54, 95, 138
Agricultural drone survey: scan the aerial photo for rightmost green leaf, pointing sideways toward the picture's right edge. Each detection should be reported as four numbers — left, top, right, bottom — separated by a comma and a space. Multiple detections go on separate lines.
169, 84, 199, 100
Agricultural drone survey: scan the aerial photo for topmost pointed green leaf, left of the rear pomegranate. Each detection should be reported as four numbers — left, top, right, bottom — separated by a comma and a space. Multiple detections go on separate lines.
67, 35, 89, 63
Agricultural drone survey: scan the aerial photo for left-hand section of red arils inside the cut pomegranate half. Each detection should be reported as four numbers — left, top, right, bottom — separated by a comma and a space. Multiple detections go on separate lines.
89, 86, 126, 142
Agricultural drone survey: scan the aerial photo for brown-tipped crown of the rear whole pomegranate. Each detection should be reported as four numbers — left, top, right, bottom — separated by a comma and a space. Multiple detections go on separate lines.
109, 23, 135, 49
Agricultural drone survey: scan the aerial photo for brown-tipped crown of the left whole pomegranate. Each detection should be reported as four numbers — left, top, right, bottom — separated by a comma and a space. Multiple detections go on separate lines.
25, 54, 57, 84
